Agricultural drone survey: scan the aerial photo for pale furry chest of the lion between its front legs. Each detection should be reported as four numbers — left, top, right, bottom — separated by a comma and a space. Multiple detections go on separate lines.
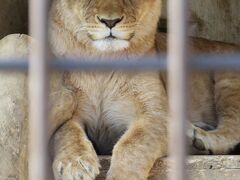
71, 73, 137, 154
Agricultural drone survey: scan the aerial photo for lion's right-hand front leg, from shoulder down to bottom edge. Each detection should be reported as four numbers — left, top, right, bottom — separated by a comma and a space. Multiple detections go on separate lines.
107, 75, 168, 180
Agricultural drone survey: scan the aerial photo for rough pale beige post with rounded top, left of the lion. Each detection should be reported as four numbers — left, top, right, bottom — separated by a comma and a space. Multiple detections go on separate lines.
0, 35, 30, 180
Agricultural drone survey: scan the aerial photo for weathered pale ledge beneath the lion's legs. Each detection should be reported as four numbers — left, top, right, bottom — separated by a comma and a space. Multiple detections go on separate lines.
97, 156, 240, 180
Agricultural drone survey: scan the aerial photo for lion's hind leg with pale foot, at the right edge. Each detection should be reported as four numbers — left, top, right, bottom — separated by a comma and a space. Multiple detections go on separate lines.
193, 73, 240, 154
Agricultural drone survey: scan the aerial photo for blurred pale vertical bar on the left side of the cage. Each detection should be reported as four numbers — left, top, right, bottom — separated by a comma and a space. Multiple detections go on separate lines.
29, 0, 50, 180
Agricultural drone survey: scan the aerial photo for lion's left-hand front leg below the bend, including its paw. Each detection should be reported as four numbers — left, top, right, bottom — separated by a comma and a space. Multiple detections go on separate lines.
53, 120, 100, 180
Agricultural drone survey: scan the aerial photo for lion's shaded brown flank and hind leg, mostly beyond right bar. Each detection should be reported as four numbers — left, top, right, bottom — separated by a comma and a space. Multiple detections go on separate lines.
156, 34, 240, 154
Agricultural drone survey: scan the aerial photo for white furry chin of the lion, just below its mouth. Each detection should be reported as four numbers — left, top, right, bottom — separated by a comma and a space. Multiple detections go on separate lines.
93, 38, 130, 52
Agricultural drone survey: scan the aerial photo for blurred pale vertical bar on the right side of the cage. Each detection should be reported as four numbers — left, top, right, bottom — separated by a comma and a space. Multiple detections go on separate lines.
168, 0, 187, 180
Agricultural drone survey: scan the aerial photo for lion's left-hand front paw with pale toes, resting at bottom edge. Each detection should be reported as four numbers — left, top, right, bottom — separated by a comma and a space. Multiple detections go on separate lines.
53, 153, 100, 180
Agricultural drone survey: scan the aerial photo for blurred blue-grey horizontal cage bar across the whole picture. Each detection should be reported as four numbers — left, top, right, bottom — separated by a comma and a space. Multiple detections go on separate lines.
0, 54, 240, 71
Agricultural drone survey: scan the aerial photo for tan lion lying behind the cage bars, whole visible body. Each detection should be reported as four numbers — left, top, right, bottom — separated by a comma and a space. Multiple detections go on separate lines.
0, 0, 240, 180
